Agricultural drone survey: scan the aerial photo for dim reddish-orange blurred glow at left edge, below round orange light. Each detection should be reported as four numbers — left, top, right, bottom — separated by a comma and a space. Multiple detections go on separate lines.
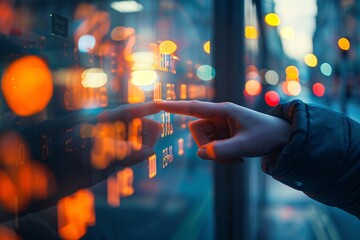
0, 133, 54, 212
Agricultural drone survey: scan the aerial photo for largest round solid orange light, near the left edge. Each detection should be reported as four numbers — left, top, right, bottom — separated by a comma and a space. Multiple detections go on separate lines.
1, 56, 53, 116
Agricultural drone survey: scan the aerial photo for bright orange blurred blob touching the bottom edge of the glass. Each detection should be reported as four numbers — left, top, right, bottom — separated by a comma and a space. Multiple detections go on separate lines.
57, 189, 95, 239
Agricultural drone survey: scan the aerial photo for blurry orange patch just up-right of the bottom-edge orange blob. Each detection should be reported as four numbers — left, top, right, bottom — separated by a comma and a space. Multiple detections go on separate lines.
107, 167, 134, 207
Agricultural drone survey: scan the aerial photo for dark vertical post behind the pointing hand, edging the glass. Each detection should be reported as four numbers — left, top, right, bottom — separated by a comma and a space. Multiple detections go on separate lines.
212, 0, 248, 239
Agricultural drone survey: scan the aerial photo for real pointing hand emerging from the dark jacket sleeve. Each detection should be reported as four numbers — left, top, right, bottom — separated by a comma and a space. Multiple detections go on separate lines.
158, 101, 291, 163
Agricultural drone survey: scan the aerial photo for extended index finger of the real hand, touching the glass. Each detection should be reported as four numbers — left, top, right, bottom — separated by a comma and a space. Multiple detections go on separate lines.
158, 100, 221, 119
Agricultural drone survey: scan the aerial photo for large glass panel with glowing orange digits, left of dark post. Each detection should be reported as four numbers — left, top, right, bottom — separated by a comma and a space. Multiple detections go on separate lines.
0, 0, 215, 239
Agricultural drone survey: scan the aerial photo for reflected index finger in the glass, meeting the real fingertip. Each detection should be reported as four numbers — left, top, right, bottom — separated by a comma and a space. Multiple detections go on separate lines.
98, 102, 161, 122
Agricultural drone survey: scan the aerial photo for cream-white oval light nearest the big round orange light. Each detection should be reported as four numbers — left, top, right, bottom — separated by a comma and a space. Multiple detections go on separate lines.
81, 68, 107, 88
